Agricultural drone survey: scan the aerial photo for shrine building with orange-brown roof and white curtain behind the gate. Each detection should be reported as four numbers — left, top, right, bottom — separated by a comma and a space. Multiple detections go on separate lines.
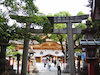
16, 41, 65, 62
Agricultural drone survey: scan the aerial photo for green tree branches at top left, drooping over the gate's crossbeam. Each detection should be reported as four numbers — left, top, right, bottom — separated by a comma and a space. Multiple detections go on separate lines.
0, 0, 48, 30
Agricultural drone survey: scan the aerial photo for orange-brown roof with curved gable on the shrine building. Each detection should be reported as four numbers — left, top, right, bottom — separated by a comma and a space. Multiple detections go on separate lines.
16, 41, 62, 50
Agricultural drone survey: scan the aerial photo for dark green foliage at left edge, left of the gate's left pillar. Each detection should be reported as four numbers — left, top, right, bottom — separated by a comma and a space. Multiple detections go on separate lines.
0, 11, 20, 41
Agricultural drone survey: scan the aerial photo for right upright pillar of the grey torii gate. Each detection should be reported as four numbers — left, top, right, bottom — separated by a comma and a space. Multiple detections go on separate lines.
67, 22, 76, 75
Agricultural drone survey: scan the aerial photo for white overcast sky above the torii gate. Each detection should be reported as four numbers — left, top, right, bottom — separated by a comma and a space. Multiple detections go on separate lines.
35, 0, 90, 16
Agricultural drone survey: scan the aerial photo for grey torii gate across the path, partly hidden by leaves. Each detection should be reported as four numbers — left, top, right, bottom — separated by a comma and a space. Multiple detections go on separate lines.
10, 15, 88, 75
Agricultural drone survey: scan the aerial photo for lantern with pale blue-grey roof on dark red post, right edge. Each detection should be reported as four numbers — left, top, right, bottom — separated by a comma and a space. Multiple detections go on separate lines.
80, 39, 100, 75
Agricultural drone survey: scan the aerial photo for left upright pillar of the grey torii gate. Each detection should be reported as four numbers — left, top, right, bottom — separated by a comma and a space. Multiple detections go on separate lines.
21, 23, 30, 75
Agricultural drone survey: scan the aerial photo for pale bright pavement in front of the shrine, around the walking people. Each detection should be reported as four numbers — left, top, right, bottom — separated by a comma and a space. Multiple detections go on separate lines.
14, 63, 77, 75
